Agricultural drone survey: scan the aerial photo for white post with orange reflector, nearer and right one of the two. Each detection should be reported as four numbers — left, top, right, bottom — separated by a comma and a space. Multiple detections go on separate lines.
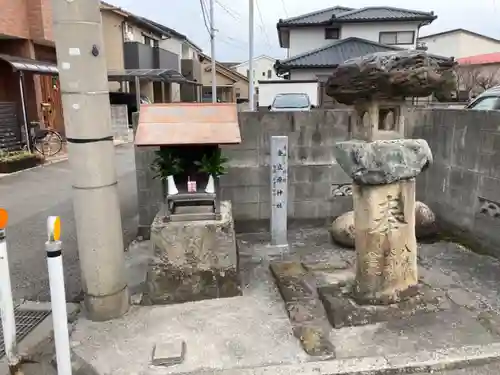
45, 216, 71, 375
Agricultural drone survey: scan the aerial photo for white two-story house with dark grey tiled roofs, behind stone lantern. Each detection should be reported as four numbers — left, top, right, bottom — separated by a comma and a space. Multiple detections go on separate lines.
275, 6, 437, 81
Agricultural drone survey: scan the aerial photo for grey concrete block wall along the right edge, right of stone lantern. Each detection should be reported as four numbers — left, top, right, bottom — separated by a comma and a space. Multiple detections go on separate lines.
407, 109, 500, 257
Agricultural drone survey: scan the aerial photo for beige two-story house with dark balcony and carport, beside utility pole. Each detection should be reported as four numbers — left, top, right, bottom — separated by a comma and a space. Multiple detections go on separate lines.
101, 2, 201, 102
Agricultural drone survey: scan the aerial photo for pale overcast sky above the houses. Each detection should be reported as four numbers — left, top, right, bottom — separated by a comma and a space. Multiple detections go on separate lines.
110, 0, 500, 61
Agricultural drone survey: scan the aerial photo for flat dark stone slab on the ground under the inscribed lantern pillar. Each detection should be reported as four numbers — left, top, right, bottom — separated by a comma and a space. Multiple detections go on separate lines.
318, 284, 450, 329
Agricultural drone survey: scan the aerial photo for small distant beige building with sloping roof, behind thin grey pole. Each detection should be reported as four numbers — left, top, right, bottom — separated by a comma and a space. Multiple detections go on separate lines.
201, 54, 249, 102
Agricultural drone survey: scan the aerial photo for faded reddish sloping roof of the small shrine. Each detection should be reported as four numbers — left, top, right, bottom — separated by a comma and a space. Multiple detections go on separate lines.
135, 103, 241, 146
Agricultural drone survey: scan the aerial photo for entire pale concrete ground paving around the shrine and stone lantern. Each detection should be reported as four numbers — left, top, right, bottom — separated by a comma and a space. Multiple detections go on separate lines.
72, 228, 500, 375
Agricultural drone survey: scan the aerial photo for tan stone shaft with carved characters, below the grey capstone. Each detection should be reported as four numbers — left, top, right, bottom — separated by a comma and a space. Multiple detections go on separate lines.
353, 179, 418, 304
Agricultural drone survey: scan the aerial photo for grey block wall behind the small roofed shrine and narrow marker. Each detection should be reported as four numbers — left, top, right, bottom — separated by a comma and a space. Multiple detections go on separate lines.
136, 110, 352, 238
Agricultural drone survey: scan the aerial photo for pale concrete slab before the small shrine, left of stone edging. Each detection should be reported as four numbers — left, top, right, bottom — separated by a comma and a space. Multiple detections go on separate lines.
68, 264, 307, 374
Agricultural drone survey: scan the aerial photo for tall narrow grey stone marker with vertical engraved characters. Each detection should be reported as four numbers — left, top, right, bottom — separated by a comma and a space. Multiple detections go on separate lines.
270, 136, 288, 246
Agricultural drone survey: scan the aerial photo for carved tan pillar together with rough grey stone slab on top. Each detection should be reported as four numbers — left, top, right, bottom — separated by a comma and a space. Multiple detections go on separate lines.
335, 139, 432, 304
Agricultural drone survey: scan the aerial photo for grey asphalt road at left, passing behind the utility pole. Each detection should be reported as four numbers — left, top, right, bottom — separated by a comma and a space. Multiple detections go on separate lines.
0, 144, 137, 301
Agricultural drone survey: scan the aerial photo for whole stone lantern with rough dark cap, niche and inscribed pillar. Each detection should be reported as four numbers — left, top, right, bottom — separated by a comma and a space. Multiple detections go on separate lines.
326, 50, 456, 305
